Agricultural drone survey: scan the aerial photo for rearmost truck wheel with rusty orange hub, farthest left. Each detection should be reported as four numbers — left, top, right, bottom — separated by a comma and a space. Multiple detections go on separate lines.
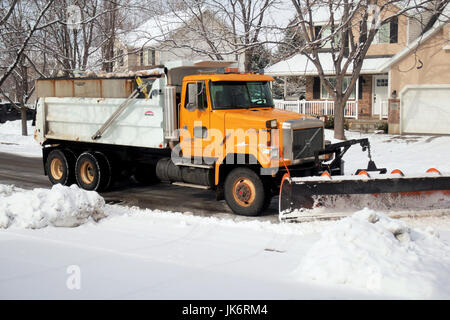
45, 149, 75, 186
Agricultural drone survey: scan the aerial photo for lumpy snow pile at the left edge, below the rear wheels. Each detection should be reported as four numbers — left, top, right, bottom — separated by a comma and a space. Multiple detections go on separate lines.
0, 184, 106, 229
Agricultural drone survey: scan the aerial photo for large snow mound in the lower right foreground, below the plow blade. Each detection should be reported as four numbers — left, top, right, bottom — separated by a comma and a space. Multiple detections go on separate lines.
294, 208, 450, 299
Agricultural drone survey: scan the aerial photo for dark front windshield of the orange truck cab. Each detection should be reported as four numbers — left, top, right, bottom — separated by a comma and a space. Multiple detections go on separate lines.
211, 81, 274, 109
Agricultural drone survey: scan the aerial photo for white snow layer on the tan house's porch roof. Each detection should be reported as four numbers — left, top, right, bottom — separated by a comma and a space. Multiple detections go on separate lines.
264, 52, 391, 76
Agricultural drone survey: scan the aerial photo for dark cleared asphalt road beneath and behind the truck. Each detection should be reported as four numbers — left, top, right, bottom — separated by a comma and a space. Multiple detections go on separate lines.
0, 152, 278, 222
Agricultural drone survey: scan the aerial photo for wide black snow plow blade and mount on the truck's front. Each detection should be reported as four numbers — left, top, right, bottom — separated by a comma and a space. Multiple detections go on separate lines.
279, 139, 450, 221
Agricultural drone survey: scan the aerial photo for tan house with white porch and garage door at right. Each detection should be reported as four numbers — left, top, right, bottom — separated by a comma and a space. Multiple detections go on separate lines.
265, 1, 450, 134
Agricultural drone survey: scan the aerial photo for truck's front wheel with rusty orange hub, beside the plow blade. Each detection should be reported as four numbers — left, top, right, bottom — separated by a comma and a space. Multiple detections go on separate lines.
224, 168, 267, 216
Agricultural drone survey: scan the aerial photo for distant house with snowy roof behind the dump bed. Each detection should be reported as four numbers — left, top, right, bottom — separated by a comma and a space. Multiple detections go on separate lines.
114, 9, 245, 72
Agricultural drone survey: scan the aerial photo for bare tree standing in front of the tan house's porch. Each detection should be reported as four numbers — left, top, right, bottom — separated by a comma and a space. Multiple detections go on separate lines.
292, 0, 449, 140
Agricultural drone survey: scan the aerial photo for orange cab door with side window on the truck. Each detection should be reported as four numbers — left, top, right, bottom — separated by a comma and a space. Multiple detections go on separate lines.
180, 80, 211, 158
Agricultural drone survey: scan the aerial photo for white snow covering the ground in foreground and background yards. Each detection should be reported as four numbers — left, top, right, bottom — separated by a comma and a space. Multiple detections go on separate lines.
0, 120, 450, 299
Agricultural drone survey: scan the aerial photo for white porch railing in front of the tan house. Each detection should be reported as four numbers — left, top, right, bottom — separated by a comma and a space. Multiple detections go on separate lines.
274, 100, 358, 119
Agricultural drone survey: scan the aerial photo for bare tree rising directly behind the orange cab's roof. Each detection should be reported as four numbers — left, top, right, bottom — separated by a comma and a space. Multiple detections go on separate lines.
123, 0, 280, 71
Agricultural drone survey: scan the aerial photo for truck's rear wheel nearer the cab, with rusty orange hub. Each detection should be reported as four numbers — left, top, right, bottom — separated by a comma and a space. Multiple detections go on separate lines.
75, 152, 111, 191
